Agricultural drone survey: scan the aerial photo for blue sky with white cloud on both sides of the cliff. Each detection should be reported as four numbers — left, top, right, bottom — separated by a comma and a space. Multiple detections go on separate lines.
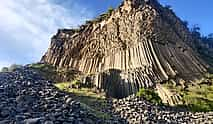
0, 0, 213, 68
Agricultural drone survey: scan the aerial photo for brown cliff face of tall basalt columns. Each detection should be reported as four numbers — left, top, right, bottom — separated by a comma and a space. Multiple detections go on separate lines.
42, 0, 206, 98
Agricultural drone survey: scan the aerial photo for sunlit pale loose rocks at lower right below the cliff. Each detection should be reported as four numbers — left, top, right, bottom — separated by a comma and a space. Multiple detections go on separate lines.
113, 95, 213, 124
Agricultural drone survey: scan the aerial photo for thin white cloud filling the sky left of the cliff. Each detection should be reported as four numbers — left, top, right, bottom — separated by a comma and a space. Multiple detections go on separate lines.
0, 0, 92, 66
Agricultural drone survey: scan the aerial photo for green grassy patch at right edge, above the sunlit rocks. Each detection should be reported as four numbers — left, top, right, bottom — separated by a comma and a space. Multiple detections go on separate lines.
163, 78, 213, 112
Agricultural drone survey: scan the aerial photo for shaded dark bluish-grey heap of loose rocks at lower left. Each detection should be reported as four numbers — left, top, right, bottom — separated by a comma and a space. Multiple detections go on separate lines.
0, 68, 125, 124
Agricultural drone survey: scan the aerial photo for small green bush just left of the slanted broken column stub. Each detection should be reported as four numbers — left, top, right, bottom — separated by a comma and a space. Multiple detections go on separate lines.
137, 88, 163, 105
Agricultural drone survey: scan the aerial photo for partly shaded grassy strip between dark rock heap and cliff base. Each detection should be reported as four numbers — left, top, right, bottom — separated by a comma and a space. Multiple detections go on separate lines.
55, 81, 112, 119
